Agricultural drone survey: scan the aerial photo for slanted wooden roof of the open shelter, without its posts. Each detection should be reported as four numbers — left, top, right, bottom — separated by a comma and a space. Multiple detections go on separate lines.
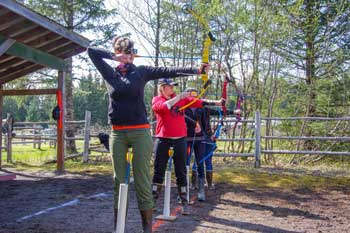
0, 0, 90, 85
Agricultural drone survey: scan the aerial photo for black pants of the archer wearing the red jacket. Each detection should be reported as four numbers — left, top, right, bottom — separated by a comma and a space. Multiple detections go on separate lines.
153, 138, 187, 187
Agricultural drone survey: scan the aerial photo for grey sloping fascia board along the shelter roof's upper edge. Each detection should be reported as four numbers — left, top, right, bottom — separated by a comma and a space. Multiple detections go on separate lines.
0, 0, 90, 47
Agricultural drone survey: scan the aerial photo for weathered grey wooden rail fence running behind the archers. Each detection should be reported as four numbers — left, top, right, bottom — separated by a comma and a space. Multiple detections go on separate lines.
3, 111, 350, 167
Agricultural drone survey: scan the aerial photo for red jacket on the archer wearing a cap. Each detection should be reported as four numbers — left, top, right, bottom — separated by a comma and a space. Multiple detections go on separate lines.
152, 95, 203, 138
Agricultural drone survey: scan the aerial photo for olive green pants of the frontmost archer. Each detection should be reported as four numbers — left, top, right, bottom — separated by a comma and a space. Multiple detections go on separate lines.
111, 129, 154, 210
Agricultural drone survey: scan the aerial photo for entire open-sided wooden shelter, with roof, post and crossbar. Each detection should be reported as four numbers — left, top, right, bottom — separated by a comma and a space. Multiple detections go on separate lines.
0, 0, 90, 175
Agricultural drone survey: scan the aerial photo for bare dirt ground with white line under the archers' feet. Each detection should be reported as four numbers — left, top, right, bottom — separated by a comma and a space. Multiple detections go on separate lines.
0, 168, 350, 233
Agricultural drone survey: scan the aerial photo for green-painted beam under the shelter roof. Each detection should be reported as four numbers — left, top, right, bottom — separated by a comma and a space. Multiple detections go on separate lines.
0, 35, 66, 70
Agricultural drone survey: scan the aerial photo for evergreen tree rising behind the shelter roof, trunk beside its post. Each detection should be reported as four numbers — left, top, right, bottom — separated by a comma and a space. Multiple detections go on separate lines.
24, 0, 118, 153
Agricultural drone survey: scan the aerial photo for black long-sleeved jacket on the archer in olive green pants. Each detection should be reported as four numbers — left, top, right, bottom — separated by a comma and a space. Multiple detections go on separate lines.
88, 48, 198, 126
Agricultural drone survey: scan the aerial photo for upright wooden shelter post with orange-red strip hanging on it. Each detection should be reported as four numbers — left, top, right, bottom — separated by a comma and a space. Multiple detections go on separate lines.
56, 71, 66, 172
